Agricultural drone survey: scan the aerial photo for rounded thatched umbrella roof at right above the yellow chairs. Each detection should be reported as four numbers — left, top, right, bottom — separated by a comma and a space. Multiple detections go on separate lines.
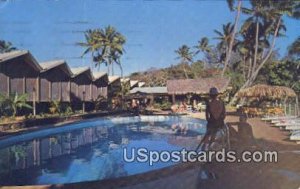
238, 84, 296, 99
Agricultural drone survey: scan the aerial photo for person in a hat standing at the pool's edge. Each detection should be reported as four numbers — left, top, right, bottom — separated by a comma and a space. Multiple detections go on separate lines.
203, 87, 226, 151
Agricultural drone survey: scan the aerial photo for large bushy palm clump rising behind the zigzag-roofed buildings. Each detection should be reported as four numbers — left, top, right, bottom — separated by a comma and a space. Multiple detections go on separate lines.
78, 26, 126, 75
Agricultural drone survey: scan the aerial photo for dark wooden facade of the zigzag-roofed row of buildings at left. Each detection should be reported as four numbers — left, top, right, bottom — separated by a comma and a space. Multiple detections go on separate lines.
0, 55, 110, 105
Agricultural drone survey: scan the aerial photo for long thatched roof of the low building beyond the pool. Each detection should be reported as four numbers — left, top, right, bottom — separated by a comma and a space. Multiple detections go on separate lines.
167, 78, 230, 94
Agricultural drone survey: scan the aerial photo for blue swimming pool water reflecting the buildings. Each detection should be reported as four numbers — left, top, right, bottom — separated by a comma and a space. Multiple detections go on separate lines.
0, 116, 206, 185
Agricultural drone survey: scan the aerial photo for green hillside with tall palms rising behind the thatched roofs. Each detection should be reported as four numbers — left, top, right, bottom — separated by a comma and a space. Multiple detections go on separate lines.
130, 1, 300, 102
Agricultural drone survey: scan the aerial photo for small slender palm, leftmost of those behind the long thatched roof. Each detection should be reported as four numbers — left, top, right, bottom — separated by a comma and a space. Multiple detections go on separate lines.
175, 45, 193, 79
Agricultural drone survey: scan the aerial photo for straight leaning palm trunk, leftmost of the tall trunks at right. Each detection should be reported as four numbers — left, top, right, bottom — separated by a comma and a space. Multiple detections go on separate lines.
222, 0, 242, 77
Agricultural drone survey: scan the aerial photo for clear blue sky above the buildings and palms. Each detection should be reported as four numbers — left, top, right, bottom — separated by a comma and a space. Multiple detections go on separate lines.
0, 0, 300, 74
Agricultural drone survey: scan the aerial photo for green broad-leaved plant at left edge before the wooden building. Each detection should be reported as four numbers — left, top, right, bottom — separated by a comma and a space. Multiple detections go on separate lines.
0, 93, 32, 117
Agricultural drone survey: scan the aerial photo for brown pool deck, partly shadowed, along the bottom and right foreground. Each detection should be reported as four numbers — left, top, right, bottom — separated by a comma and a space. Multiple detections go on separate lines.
2, 111, 300, 189
